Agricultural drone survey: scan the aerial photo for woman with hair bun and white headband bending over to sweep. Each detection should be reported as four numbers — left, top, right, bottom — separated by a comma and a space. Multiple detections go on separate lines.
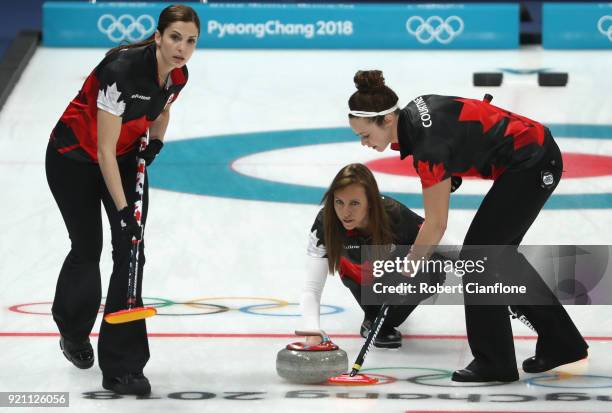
348, 70, 588, 382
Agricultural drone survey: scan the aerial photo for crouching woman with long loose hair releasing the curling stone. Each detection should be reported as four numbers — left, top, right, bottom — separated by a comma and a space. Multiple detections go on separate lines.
299, 163, 444, 348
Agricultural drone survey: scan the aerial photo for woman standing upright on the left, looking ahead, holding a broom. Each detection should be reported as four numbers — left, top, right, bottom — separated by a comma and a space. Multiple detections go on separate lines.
45, 5, 200, 394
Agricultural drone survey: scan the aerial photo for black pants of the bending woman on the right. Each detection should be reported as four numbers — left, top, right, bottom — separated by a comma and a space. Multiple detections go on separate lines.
463, 131, 588, 378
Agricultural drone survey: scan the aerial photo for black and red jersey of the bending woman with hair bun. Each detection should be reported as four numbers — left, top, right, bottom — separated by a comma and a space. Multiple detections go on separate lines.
391, 95, 545, 188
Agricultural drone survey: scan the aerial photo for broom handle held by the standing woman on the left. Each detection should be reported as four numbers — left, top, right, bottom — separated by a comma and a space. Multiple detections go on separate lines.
127, 131, 149, 310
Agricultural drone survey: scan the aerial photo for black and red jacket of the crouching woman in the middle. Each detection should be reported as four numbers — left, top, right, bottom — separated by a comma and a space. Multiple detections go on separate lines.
308, 196, 423, 285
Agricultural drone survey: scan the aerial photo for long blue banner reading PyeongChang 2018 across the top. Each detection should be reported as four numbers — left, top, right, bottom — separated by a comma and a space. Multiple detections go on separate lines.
43, 2, 519, 49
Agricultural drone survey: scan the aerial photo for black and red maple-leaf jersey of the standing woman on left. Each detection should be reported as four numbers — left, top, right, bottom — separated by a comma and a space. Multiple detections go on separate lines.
51, 43, 188, 162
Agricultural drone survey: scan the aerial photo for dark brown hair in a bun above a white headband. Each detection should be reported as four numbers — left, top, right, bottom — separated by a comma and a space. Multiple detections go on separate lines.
349, 70, 399, 125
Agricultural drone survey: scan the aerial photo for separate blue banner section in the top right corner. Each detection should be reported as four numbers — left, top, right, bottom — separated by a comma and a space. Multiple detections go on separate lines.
542, 3, 612, 49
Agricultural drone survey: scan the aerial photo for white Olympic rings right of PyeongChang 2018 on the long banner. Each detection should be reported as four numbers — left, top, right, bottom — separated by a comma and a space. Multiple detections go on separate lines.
406, 16, 464, 44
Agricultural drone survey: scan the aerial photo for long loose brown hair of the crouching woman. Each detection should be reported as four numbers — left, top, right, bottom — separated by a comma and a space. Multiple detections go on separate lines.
321, 163, 393, 274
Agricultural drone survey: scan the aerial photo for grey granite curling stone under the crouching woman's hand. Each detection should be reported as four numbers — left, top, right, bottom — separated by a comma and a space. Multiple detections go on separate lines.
276, 341, 348, 384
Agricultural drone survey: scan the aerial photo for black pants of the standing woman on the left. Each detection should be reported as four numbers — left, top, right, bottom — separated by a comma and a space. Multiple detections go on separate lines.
45, 145, 149, 376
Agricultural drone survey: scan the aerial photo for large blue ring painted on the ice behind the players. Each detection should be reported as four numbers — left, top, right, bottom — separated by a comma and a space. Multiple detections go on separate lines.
149, 124, 612, 209
